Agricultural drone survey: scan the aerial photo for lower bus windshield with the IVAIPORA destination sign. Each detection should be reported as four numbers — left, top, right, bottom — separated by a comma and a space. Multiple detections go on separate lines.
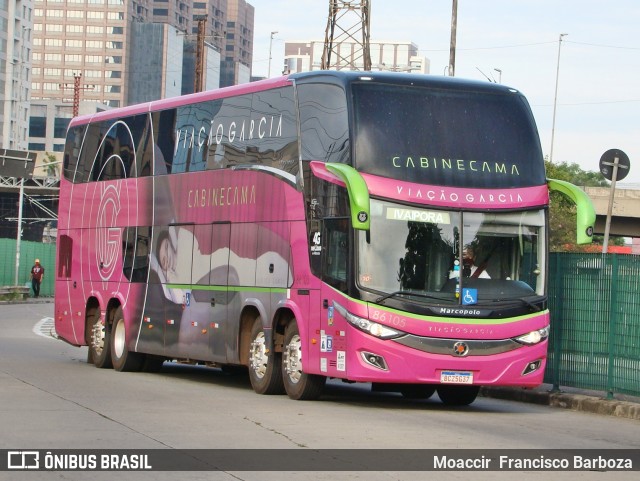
357, 199, 545, 304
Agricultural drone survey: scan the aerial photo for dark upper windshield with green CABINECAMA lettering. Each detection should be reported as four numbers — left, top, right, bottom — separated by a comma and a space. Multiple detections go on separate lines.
352, 82, 545, 188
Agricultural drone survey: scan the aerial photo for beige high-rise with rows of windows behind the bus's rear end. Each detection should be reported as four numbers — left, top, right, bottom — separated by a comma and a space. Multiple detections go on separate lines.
32, 0, 152, 107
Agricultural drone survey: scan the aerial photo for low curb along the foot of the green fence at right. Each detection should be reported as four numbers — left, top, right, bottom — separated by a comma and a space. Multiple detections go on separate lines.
480, 387, 640, 421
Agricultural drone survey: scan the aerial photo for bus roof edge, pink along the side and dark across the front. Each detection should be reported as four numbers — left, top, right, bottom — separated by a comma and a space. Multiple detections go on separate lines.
69, 70, 518, 127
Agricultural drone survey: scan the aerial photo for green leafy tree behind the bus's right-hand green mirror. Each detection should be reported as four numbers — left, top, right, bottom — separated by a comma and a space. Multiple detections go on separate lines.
545, 160, 621, 252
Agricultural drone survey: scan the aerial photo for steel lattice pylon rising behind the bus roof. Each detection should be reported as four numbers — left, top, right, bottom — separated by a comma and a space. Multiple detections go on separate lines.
321, 0, 371, 70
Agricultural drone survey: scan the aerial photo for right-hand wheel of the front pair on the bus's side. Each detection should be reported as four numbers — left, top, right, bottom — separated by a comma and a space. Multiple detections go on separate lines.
282, 319, 327, 401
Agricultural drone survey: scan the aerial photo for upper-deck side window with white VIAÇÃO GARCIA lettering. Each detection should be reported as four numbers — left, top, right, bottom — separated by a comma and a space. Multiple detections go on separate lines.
152, 87, 298, 175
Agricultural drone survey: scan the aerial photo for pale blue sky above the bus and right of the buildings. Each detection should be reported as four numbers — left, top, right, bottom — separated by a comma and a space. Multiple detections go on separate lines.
248, 0, 640, 184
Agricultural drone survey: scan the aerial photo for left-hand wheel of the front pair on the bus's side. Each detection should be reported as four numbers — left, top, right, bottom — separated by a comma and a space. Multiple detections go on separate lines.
249, 316, 284, 394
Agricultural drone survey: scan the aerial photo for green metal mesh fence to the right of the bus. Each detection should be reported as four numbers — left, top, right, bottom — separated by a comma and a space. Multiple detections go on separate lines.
545, 253, 640, 397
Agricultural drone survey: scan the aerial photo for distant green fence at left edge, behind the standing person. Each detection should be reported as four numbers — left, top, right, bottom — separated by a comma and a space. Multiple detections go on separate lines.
0, 239, 56, 296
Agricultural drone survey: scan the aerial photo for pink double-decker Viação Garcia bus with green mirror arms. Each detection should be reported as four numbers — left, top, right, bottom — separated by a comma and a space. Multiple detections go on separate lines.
55, 71, 595, 405
